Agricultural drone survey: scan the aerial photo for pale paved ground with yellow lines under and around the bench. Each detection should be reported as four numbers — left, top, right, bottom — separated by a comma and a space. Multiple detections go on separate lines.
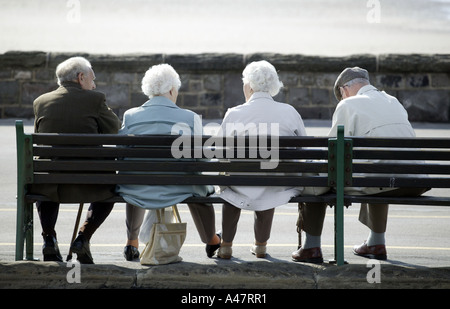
0, 120, 450, 291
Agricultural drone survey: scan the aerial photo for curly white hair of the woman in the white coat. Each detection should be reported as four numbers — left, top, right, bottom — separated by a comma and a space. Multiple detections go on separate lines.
242, 60, 283, 96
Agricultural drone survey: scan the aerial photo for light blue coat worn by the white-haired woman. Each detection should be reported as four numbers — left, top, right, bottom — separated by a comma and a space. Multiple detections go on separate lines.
116, 96, 213, 209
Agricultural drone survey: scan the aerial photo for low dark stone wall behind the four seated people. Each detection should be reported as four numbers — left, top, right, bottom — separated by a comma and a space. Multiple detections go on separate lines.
0, 52, 450, 122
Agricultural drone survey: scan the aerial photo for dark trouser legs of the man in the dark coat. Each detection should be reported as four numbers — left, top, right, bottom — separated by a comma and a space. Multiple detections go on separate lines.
36, 201, 114, 240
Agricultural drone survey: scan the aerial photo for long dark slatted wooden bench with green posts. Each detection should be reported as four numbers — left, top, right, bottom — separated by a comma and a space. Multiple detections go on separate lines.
16, 121, 450, 265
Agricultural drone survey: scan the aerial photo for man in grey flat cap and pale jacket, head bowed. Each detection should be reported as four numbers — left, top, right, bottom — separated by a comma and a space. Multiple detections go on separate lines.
292, 67, 429, 263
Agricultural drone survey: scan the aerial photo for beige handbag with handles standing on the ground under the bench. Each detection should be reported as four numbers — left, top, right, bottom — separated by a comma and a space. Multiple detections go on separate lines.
140, 205, 186, 265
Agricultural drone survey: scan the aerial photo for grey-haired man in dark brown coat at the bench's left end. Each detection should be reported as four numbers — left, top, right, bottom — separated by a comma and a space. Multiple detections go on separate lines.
31, 57, 120, 264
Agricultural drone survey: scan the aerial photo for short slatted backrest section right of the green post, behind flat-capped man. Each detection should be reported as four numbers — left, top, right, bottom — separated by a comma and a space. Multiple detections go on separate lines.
345, 137, 450, 188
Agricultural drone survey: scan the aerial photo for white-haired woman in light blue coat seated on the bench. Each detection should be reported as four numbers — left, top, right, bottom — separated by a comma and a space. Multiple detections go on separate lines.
116, 64, 220, 260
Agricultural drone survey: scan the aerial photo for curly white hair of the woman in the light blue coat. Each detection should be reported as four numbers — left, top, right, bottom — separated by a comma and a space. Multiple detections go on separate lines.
141, 63, 181, 99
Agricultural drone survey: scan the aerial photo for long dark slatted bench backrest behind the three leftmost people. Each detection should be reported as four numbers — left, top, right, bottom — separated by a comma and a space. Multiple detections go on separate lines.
16, 121, 337, 187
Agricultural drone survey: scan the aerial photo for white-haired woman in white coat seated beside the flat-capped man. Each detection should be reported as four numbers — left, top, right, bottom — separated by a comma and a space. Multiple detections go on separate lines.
217, 60, 306, 259
